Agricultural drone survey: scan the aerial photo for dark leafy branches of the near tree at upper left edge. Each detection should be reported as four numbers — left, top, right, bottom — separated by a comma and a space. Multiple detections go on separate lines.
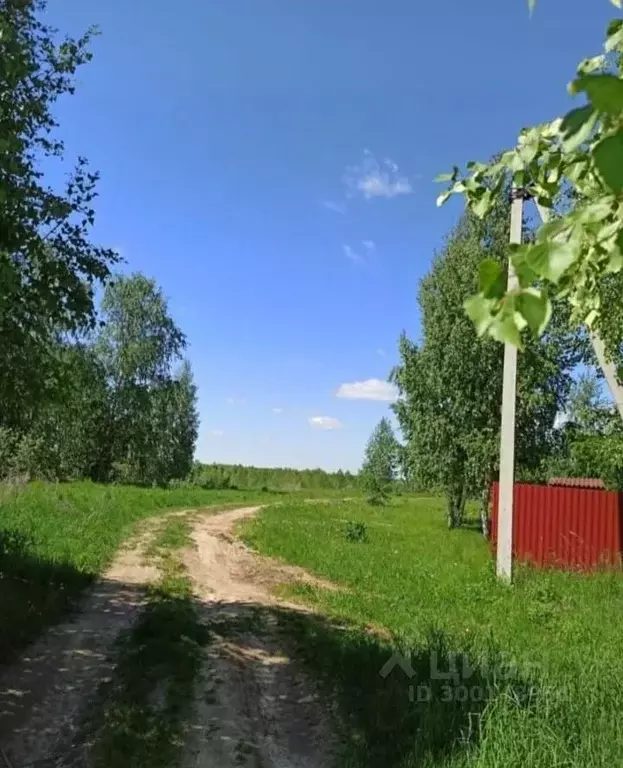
0, 0, 118, 429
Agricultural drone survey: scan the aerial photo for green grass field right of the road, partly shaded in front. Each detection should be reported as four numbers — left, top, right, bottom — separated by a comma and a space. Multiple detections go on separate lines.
242, 499, 623, 768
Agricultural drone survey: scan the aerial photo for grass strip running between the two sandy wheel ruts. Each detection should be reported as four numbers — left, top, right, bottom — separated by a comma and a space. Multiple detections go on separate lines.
90, 518, 208, 768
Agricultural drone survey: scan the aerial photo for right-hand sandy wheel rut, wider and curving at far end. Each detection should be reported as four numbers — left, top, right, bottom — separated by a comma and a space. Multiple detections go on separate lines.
182, 507, 335, 768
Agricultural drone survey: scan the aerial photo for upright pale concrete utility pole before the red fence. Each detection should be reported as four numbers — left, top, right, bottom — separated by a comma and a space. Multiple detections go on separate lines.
497, 187, 525, 582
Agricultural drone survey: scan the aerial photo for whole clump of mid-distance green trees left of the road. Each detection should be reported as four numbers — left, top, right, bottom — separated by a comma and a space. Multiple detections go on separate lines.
0, 275, 198, 485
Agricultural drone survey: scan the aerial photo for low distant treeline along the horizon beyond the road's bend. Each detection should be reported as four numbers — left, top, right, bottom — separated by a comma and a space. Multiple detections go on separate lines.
189, 462, 358, 491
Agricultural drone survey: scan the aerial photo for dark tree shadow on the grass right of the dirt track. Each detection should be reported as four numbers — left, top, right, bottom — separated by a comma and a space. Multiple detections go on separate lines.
215, 604, 535, 768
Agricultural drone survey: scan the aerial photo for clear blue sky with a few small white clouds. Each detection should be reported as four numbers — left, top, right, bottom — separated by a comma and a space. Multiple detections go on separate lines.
47, 0, 613, 469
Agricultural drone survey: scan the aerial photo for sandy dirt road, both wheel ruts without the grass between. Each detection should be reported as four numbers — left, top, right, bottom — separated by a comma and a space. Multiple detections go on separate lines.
0, 507, 333, 768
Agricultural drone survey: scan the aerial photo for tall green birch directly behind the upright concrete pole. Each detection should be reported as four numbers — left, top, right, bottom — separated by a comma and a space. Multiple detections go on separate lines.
391, 198, 585, 532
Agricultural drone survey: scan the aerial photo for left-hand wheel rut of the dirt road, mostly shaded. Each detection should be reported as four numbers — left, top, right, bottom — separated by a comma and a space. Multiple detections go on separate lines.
0, 517, 166, 768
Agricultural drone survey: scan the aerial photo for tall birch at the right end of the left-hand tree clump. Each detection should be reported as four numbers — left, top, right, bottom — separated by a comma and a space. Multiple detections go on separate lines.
94, 274, 198, 484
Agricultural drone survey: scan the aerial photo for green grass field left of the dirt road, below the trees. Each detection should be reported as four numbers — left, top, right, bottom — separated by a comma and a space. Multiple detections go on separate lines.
0, 482, 282, 663
